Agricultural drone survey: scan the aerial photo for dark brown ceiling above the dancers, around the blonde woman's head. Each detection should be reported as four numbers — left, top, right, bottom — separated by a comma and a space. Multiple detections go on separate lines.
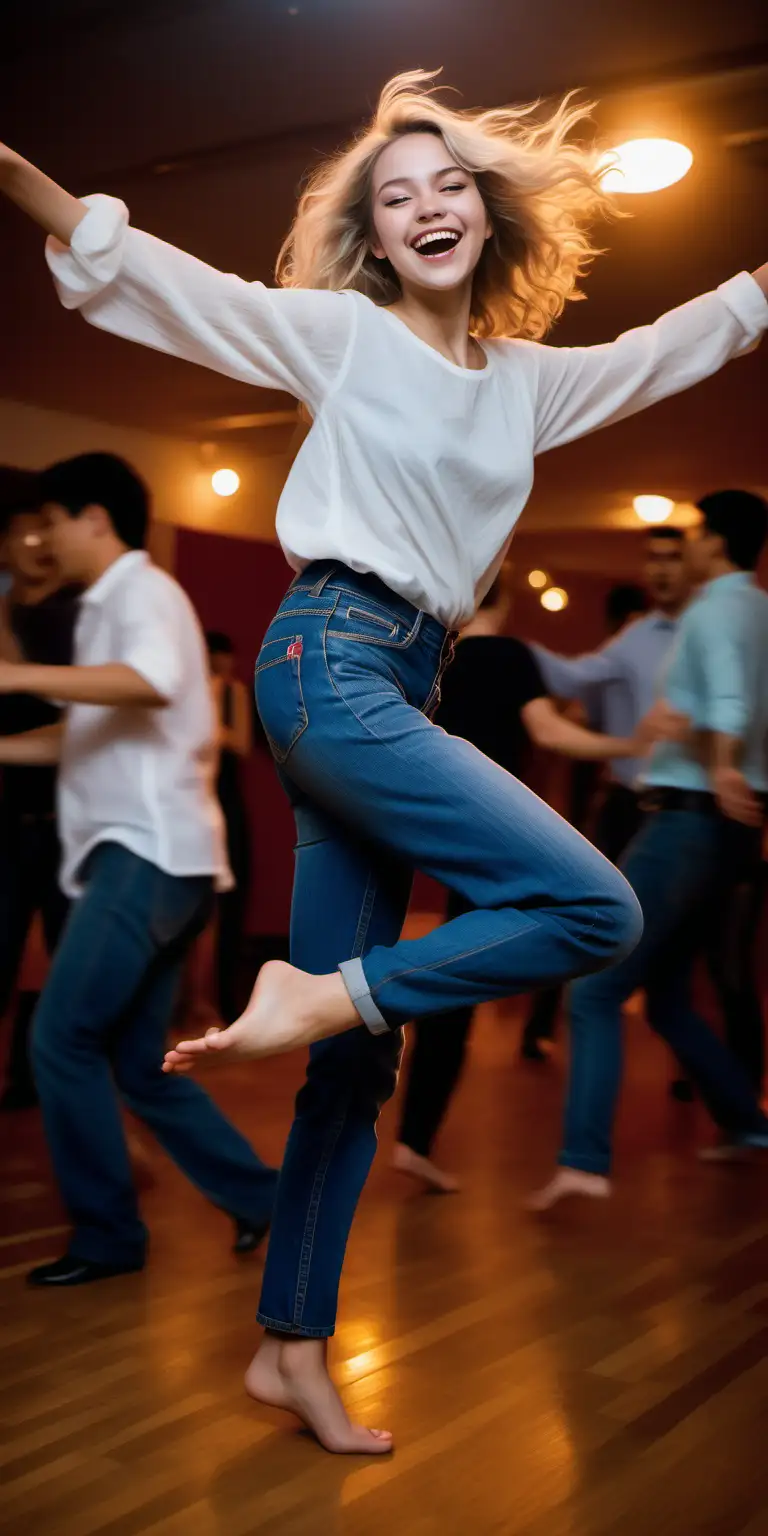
0, 0, 768, 522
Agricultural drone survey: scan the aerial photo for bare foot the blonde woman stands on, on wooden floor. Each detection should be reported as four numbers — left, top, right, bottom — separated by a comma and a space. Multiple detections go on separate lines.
246, 1333, 392, 1456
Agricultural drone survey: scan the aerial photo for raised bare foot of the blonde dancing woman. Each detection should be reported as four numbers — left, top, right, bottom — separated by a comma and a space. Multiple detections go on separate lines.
163, 960, 361, 1072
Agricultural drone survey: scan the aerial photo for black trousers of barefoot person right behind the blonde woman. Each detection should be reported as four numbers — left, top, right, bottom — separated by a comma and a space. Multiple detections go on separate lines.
398, 891, 475, 1157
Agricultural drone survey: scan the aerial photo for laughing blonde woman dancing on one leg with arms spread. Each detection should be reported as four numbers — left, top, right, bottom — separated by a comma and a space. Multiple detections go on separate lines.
0, 74, 768, 1453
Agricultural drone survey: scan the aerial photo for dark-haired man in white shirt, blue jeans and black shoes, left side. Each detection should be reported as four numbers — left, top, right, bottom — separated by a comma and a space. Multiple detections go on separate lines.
0, 453, 276, 1286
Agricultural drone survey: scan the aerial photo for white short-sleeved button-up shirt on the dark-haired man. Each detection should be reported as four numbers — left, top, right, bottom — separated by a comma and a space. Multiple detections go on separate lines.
58, 550, 232, 895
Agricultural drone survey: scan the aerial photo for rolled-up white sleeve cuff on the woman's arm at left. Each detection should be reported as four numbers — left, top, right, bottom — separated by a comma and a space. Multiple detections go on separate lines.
46, 192, 127, 309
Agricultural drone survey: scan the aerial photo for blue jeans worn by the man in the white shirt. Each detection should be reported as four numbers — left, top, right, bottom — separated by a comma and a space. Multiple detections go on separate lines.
32, 843, 276, 1267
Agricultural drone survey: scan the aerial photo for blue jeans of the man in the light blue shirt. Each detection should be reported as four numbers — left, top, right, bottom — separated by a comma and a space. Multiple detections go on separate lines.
559, 809, 766, 1174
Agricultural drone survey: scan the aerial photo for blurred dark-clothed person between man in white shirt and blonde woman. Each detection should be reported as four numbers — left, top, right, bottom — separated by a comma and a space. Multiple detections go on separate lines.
206, 630, 253, 1025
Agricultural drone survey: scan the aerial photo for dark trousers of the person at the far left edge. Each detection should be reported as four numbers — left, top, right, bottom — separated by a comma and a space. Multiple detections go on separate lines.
0, 809, 68, 1098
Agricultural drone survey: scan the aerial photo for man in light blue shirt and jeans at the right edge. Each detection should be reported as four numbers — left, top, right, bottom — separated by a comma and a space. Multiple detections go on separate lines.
533, 492, 768, 1209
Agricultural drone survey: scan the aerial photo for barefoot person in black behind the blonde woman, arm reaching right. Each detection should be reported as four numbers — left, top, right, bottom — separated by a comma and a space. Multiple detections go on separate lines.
393, 570, 654, 1193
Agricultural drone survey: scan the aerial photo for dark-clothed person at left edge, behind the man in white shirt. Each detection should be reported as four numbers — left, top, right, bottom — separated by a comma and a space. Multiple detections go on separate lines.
0, 465, 78, 1111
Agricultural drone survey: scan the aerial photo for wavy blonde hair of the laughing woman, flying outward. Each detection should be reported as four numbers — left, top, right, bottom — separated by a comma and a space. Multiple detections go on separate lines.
276, 69, 614, 339
